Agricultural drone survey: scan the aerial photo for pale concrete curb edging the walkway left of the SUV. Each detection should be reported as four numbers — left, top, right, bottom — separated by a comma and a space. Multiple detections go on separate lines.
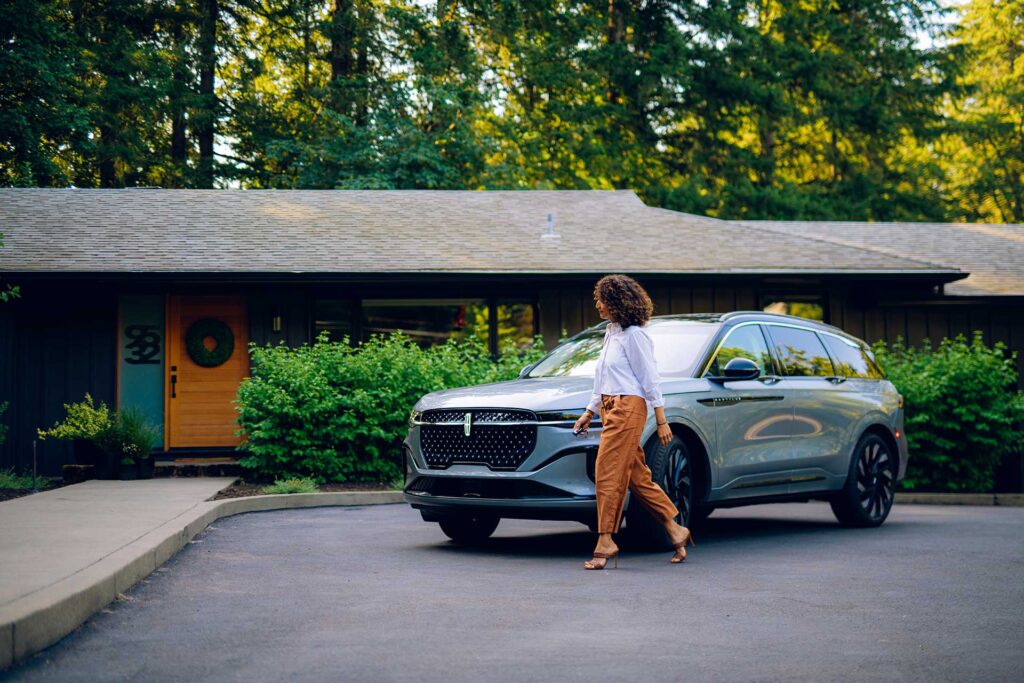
0, 492, 403, 672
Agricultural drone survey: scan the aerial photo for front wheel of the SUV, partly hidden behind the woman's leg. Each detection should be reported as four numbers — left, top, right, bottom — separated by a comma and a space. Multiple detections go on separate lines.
626, 436, 712, 548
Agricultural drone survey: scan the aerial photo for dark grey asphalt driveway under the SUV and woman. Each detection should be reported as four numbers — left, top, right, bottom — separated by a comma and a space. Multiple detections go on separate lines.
8, 504, 1024, 683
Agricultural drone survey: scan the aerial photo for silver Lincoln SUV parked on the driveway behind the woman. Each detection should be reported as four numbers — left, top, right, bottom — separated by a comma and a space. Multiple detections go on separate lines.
403, 311, 907, 544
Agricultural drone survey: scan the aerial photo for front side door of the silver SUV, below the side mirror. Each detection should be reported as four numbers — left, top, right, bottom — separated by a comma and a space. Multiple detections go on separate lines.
698, 323, 793, 500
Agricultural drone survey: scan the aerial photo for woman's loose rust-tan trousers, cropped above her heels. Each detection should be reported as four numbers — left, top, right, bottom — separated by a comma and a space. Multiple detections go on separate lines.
594, 394, 679, 533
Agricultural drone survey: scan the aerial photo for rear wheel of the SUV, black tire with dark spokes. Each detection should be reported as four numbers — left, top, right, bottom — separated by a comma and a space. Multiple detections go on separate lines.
830, 433, 896, 527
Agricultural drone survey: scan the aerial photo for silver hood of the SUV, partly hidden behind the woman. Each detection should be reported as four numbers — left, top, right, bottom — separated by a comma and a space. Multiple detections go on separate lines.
415, 377, 708, 411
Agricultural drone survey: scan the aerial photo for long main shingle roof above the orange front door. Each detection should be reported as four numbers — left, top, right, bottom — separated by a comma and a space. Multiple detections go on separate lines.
0, 188, 955, 279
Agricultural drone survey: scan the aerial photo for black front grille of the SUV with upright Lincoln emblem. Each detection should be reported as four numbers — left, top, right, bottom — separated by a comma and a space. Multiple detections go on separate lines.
420, 409, 537, 470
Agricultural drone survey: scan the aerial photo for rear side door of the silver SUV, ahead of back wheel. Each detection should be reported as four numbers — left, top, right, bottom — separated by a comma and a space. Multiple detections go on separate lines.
765, 323, 861, 485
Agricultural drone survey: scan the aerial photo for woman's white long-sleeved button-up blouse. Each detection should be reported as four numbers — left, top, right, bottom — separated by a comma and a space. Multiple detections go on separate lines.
587, 323, 665, 415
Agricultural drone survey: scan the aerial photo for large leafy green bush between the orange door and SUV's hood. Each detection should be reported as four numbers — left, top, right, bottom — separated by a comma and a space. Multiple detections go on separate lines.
238, 332, 544, 482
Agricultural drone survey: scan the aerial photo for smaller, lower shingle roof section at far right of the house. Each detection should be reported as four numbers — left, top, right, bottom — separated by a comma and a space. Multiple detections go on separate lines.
738, 220, 1024, 296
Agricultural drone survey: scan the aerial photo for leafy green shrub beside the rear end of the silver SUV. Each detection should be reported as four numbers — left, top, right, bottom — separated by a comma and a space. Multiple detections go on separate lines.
873, 332, 1024, 492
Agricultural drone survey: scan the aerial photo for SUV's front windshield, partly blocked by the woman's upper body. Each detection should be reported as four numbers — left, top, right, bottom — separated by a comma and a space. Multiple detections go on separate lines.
526, 321, 720, 377
